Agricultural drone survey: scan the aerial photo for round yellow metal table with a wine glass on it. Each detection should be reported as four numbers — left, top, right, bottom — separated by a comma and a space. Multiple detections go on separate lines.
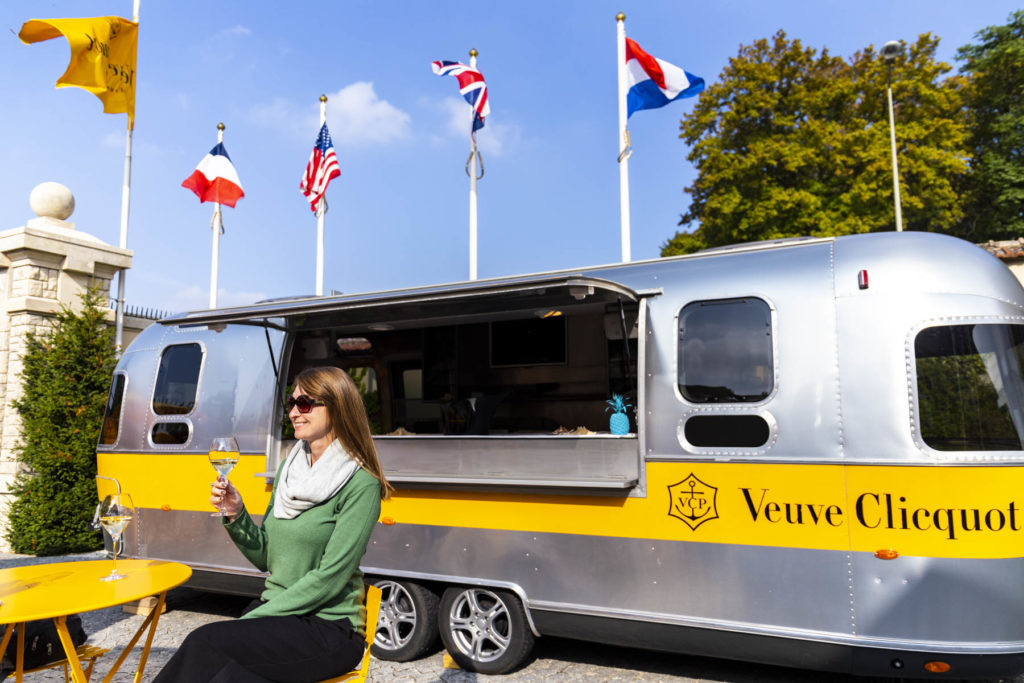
0, 560, 191, 683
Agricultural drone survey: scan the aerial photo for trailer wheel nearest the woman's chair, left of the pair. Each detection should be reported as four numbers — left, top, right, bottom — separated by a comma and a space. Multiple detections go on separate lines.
370, 580, 438, 661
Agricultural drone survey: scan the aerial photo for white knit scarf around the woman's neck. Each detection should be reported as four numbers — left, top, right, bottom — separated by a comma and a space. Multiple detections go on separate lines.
273, 439, 359, 519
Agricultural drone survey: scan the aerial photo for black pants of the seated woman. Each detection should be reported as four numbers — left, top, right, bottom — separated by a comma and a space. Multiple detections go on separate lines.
154, 616, 366, 683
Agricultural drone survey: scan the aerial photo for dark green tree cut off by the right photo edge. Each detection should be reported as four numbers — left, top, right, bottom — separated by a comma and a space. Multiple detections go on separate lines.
956, 10, 1024, 242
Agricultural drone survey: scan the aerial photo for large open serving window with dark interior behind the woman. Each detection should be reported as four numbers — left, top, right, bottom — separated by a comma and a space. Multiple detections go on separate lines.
285, 295, 639, 436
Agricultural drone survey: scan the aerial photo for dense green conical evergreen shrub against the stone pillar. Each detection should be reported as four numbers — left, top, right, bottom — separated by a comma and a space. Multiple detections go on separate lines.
6, 290, 117, 555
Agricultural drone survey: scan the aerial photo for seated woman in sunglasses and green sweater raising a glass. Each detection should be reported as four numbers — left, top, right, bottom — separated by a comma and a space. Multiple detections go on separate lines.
155, 368, 391, 683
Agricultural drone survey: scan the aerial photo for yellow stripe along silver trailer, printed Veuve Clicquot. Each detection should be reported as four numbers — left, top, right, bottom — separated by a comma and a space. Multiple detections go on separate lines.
99, 454, 1024, 558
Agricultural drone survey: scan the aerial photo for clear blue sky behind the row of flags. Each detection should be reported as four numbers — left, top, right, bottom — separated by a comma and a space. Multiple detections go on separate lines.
0, 0, 1020, 311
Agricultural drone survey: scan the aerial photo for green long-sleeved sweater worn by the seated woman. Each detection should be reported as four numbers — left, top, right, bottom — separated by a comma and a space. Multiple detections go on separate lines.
224, 469, 381, 633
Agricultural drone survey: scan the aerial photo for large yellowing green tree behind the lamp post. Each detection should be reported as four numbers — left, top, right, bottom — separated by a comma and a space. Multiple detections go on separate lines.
662, 31, 967, 256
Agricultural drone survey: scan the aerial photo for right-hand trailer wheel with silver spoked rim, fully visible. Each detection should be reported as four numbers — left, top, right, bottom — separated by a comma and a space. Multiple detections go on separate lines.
440, 586, 534, 674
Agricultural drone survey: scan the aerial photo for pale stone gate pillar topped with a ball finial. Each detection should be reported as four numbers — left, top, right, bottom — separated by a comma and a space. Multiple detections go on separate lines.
0, 182, 132, 551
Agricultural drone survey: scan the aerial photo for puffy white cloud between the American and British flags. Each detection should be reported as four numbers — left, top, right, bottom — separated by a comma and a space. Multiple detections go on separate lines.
327, 81, 412, 144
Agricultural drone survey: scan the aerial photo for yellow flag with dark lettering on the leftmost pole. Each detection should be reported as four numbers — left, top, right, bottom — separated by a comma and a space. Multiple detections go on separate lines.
17, 16, 138, 128
